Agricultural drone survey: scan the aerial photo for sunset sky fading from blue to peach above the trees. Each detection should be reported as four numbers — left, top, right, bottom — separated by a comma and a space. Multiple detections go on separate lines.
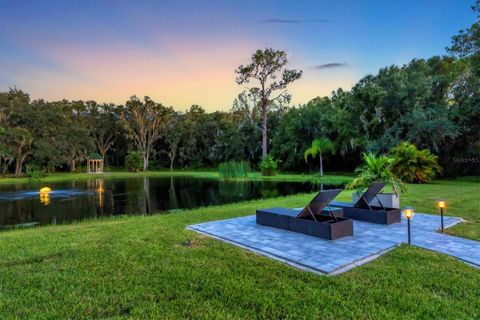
0, 0, 475, 111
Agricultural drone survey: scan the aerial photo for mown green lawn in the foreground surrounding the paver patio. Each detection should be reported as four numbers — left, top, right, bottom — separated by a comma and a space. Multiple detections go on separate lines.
0, 181, 480, 319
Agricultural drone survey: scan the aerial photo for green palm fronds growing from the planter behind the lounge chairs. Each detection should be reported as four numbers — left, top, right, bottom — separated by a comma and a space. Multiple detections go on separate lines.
347, 153, 406, 194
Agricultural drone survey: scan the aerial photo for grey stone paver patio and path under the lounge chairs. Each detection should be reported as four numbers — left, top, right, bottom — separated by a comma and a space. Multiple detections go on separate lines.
188, 213, 480, 274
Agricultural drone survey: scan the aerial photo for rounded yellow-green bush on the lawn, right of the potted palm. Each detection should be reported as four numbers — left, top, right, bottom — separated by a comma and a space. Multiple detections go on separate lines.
390, 142, 442, 183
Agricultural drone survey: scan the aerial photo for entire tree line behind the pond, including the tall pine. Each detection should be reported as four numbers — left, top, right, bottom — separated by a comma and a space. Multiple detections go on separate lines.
0, 1, 480, 175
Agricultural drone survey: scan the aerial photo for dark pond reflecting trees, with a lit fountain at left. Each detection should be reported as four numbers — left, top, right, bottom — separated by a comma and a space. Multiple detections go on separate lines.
0, 177, 338, 228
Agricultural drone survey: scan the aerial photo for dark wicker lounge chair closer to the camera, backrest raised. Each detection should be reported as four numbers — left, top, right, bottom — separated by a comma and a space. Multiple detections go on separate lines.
256, 189, 353, 240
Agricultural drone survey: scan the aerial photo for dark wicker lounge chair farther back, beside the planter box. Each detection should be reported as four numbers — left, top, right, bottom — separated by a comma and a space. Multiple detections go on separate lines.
330, 182, 401, 224
